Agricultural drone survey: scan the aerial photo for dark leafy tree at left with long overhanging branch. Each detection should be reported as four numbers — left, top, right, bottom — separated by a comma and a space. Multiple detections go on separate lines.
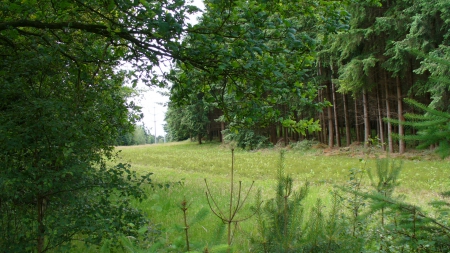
0, 0, 200, 252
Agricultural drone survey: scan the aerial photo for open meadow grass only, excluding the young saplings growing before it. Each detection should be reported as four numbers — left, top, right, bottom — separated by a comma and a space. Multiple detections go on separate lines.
110, 141, 450, 252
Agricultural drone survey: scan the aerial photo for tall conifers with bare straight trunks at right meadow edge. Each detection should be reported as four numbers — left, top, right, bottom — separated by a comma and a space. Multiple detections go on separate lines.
319, 0, 450, 153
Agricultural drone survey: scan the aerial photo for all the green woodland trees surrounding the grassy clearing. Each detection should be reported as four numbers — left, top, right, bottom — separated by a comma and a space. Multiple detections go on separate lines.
0, 0, 450, 253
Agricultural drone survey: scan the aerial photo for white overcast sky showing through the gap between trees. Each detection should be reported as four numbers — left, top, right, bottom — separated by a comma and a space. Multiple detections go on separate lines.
134, 0, 204, 136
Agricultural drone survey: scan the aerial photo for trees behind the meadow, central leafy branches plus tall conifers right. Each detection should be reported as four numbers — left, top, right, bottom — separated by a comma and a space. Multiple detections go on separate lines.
168, 0, 450, 153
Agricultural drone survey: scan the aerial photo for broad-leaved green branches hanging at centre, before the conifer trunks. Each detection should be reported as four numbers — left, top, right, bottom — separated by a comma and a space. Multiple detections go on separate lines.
168, 1, 347, 145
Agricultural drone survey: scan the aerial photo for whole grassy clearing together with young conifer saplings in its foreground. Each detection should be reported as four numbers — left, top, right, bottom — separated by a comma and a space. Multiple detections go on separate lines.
94, 142, 450, 252
